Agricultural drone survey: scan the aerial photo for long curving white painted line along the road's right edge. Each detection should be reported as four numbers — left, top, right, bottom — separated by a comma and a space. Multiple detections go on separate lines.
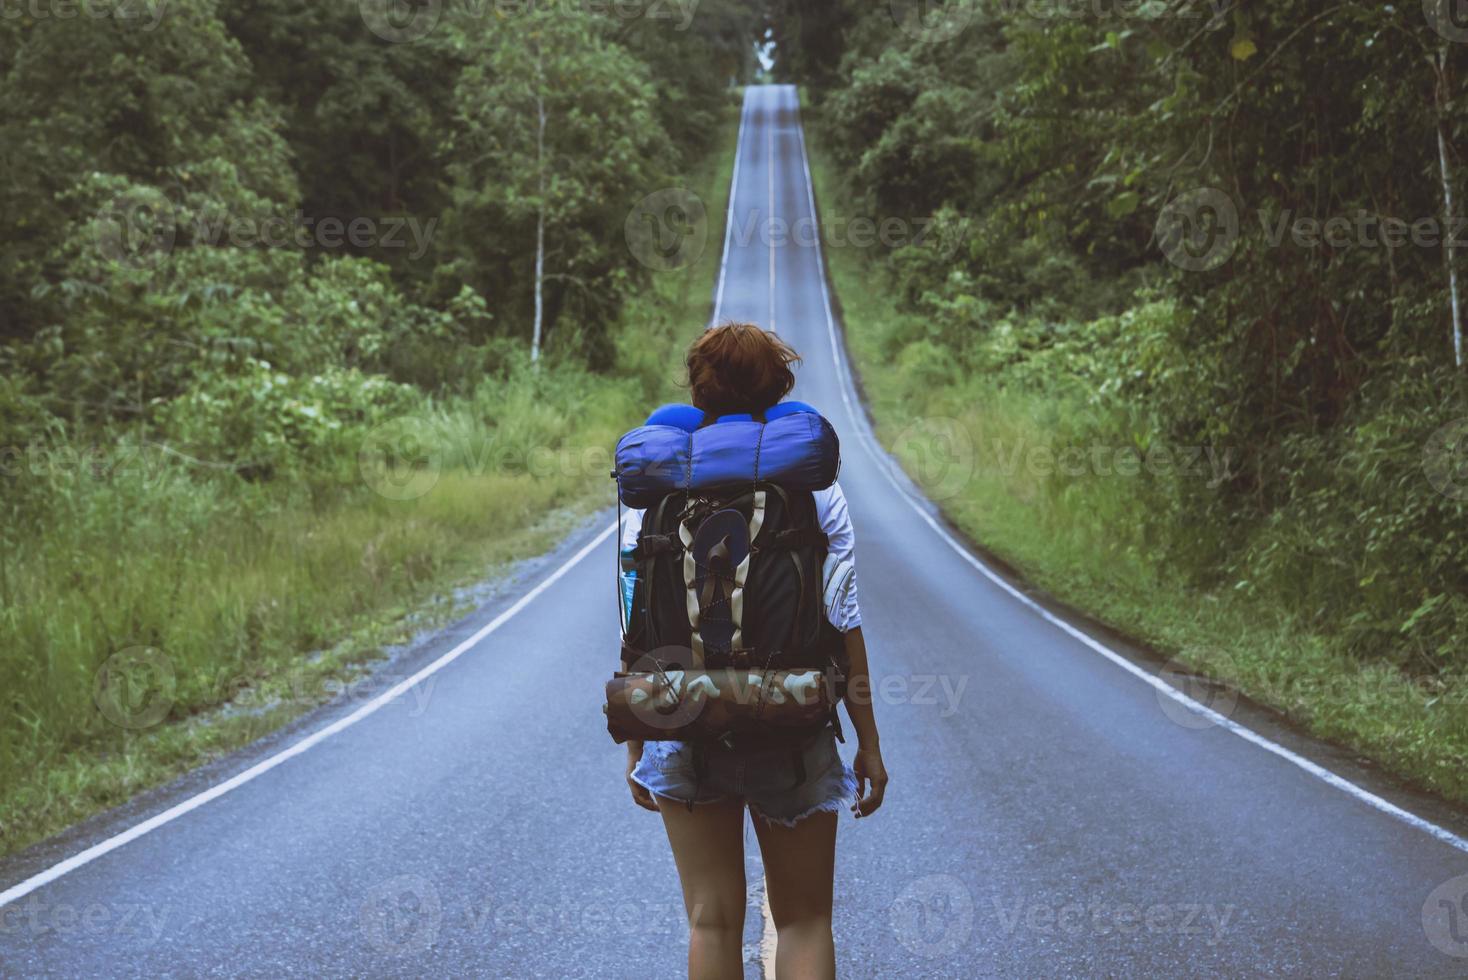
797, 89, 1468, 854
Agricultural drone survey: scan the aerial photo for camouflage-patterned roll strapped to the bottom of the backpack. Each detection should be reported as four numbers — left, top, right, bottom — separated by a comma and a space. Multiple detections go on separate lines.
603, 668, 840, 742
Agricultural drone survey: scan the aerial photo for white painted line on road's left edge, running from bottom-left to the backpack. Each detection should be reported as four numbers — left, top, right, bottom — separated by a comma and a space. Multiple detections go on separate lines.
0, 524, 617, 908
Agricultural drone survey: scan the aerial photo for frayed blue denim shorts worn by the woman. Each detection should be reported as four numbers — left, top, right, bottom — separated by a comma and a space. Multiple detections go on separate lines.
633, 728, 856, 827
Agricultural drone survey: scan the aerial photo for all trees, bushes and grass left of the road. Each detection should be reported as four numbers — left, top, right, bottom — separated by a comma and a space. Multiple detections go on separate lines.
0, 0, 753, 854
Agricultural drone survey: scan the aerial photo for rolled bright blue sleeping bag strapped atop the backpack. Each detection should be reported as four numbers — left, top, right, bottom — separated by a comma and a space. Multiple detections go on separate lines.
617, 402, 841, 508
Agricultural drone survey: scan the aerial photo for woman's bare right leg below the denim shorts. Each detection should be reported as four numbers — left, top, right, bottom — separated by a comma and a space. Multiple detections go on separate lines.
755, 813, 837, 980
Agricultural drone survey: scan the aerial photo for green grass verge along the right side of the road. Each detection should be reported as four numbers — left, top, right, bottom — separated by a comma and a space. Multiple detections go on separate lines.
812, 105, 1468, 802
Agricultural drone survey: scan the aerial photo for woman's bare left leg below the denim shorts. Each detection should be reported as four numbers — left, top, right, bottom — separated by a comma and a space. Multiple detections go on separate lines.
658, 797, 746, 980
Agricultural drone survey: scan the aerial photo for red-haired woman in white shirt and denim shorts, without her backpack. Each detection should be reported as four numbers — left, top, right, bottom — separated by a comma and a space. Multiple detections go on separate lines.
622, 323, 887, 980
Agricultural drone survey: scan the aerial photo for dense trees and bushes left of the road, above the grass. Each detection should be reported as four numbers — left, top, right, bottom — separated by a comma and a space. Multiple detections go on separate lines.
0, 0, 752, 410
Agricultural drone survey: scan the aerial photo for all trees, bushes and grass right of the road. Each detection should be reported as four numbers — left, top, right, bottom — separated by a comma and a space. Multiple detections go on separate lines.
775, 1, 1468, 801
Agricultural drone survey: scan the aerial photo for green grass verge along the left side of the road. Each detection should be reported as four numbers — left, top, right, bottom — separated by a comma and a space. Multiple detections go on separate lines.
0, 95, 737, 854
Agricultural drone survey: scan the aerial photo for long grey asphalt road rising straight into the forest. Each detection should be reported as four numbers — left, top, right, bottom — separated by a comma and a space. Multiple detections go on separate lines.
0, 87, 1468, 979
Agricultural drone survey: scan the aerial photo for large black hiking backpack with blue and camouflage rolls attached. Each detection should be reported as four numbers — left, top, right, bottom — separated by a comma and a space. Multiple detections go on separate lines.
606, 404, 844, 744
